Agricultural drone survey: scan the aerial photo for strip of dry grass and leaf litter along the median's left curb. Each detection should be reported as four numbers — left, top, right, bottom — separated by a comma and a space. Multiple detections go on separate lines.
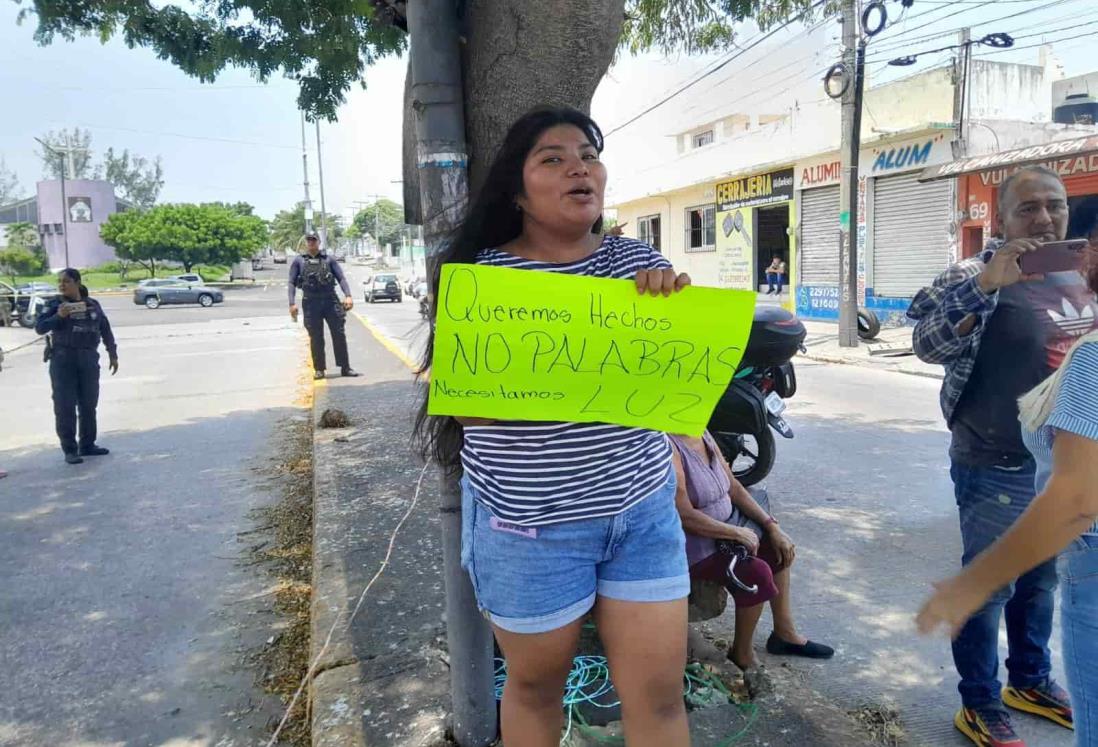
253, 420, 313, 747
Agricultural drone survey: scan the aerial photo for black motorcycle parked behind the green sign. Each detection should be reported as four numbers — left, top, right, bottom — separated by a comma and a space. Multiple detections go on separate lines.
709, 306, 807, 487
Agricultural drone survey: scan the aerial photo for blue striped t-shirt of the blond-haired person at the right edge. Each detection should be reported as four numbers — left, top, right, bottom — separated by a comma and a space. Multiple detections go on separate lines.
1022, 343, 1098, 536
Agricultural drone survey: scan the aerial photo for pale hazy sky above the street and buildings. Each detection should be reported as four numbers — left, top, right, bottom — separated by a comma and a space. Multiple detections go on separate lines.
0, 0, 1098, 218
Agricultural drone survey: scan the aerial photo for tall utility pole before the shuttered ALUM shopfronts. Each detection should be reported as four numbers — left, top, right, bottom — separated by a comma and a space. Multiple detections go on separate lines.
839, 0, 865, 347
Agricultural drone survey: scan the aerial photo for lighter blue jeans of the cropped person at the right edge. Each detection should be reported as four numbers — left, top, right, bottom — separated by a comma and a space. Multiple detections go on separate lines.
1056, 535, 1098, 747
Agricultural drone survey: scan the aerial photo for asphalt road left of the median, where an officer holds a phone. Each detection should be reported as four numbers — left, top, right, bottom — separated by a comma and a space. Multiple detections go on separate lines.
0, 283, 309, 747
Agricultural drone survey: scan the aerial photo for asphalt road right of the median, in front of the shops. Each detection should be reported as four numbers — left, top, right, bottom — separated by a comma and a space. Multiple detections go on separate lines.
358, 294, 1073, 747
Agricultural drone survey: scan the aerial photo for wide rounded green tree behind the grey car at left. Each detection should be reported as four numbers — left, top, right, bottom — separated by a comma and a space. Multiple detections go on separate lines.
99, 203, 267, 270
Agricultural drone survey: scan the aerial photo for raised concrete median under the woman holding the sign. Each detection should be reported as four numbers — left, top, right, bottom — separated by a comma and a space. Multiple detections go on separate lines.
311, 322, 872, 747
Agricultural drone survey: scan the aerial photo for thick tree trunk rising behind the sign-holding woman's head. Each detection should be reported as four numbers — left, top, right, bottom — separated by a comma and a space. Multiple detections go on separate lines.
463, 0, 625, 193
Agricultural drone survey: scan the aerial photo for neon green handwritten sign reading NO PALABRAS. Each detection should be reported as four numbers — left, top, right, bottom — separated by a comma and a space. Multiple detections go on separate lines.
428, 265, 755, 435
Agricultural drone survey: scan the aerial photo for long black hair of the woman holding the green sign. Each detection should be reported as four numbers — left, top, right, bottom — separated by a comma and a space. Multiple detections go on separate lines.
413, 107, 603, 472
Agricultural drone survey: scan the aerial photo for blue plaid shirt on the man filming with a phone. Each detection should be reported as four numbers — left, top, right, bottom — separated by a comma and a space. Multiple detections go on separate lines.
907, 238, 1004, 426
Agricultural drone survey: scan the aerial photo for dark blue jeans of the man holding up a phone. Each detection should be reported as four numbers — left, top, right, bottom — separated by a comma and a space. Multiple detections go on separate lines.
950, 461, 1056, 707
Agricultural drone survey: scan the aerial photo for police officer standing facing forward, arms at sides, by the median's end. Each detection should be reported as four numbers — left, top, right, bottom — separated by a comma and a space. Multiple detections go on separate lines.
290, 233, 358, 379
